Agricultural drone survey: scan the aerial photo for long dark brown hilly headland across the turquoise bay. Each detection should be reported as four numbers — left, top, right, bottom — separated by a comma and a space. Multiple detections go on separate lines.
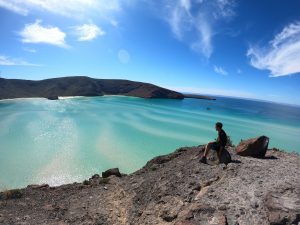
0, 77, 184, 100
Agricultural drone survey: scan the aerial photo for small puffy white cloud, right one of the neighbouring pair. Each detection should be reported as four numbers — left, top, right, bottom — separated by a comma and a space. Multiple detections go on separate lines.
74, 24, 105, 41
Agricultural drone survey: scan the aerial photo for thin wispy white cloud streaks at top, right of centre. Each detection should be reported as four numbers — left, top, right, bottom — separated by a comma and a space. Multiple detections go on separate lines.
151, 0, 235, 58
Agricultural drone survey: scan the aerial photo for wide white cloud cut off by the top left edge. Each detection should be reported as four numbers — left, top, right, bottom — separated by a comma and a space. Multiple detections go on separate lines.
0, 0, 121, 18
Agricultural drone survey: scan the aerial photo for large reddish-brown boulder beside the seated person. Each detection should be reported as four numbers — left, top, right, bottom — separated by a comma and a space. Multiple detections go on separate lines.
236, 136, 269, 158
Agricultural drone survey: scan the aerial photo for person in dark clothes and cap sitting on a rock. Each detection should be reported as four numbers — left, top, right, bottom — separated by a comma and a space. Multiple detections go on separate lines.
200, 122, 227, 163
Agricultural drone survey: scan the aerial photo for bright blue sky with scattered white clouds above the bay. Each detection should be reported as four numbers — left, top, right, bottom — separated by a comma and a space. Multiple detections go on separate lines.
0, 0, 300, 105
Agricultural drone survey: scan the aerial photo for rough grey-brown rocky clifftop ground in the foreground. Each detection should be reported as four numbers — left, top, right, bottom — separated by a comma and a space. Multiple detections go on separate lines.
0, 146, 300, 225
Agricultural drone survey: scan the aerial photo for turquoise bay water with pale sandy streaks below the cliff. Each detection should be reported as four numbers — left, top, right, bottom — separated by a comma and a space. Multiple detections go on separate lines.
0, 96, 300, 189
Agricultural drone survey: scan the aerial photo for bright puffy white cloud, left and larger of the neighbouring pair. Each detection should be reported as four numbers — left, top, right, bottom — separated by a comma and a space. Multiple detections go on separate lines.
20, 20, 68, 48
